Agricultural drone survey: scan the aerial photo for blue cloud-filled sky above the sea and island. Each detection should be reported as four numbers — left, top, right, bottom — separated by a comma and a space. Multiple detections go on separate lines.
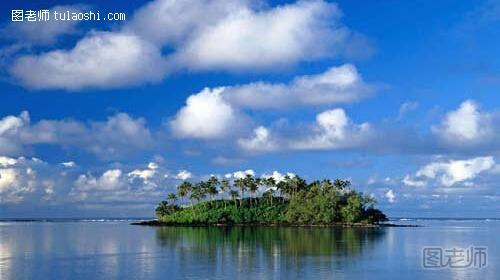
0, 0, 500, 218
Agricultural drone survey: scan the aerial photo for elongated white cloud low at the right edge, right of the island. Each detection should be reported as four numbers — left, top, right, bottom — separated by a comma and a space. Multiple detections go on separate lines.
403, 156, 495, 187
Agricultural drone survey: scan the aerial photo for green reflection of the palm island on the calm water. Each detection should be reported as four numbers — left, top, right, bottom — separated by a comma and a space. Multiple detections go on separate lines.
156, 227, 385, 276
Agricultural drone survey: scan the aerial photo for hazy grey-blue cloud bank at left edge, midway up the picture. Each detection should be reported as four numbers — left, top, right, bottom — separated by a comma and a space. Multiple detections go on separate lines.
0, 112, 153, 159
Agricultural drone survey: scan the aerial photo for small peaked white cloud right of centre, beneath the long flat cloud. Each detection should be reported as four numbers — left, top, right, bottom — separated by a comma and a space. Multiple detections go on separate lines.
290, 109, 371, 150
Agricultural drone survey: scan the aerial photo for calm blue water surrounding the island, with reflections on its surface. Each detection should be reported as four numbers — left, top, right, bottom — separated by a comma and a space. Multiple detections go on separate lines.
0, 220, 500, 280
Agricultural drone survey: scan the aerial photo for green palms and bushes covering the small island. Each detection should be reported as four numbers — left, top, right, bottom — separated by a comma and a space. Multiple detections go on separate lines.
156, 175, 387, 225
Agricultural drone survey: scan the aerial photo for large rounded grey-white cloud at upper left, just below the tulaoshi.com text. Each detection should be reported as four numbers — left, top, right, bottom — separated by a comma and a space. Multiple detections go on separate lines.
10, 32, 165, 90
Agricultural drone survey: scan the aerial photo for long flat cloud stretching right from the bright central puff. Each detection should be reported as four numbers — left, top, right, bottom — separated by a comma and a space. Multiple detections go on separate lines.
222, 64, 374, 109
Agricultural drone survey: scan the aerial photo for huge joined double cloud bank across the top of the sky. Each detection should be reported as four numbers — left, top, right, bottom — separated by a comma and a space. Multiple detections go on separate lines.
9, 0, 359, 89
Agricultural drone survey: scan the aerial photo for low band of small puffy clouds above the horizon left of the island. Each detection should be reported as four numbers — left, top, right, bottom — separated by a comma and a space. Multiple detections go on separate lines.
0, 157, 184, 210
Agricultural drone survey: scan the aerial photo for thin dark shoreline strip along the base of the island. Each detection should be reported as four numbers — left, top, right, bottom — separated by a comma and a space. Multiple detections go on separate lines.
130, 220, 422, 228
